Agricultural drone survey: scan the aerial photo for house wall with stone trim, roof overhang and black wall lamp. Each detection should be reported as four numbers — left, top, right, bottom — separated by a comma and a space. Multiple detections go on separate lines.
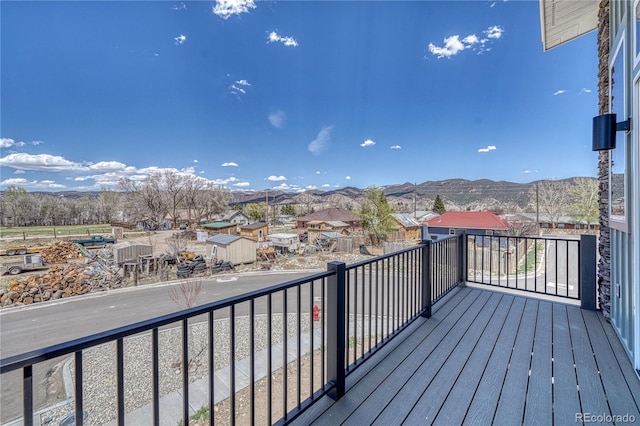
539, 0, 640, 371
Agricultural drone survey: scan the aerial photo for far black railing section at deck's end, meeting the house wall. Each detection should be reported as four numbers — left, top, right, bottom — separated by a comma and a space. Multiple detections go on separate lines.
466, 235, 596, 309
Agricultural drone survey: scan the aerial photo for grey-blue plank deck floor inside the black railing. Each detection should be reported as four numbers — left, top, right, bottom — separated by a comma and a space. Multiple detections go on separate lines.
294, 287, 640, 425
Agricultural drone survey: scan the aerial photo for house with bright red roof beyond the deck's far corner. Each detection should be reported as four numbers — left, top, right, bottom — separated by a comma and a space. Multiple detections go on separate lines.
427, 212, 509, 236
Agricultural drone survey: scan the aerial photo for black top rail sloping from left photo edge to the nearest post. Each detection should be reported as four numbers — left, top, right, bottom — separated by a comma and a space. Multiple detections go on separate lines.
0, 270, 335, 374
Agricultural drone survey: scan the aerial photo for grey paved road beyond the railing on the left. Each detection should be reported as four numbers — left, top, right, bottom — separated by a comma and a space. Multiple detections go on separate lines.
0, 271, 313, 424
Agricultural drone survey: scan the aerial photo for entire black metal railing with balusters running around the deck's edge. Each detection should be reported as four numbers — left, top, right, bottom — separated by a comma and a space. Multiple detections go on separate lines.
6, 234, 595, 425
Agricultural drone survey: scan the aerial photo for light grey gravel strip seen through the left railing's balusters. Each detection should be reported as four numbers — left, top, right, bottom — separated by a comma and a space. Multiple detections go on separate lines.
40, 315, 311, 425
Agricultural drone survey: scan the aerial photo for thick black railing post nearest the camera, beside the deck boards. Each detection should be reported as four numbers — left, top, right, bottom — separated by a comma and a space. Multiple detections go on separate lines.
326, 262, 347, 401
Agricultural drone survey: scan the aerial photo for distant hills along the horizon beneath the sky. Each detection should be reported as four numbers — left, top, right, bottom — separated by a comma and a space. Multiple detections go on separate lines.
7, 178, 592, 212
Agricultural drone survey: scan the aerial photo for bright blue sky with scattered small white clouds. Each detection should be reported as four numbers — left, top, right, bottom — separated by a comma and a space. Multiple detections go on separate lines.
0, 0, 597, 191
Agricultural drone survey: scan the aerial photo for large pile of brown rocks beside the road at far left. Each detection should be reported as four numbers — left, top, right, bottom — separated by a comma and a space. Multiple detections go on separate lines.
0, 265, 122, 307
